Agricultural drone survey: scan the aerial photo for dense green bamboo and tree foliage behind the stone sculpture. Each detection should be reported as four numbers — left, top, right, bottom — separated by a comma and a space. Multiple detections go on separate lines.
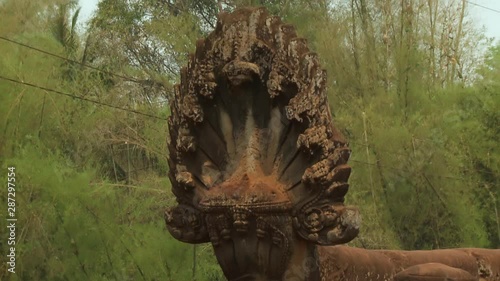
0, 0, 500, 280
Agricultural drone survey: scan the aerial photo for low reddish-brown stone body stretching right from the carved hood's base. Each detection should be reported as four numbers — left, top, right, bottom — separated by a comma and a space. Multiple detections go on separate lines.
318, 246, 500, 281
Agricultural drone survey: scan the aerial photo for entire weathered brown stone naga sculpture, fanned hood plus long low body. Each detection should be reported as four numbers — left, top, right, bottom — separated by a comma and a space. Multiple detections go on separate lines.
165, 8, 500, 281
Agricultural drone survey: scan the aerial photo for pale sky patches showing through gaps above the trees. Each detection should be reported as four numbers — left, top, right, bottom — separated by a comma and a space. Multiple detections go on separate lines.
79, 0, 500, 42
